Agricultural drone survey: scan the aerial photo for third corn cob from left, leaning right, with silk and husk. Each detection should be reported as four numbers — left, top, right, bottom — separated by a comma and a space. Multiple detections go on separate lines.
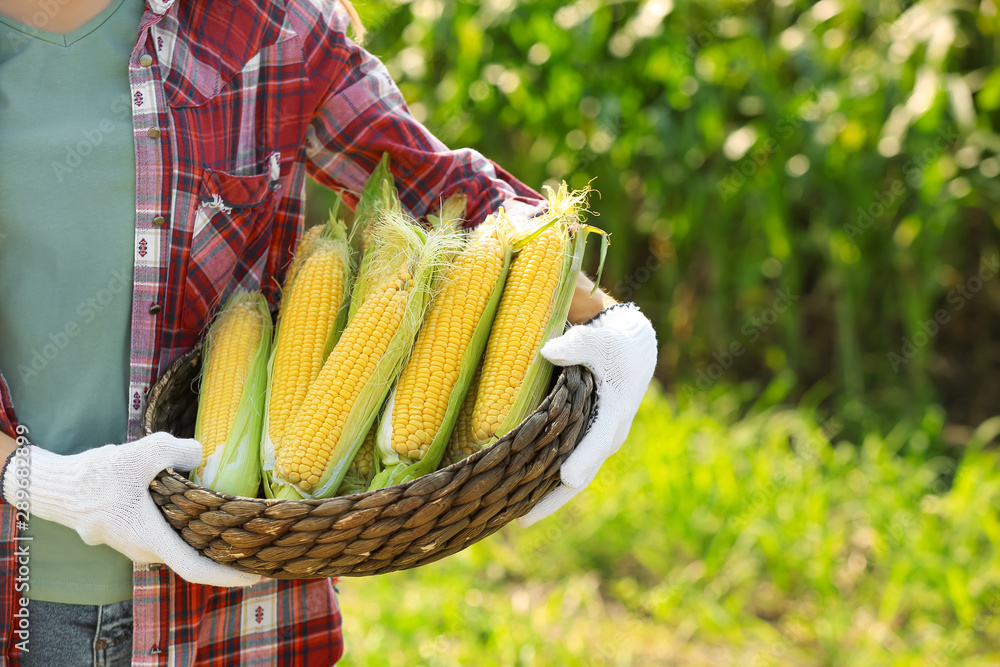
272, 206, 456, 498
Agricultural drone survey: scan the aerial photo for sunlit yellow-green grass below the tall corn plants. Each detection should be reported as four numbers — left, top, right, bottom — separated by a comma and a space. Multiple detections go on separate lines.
340, 388, 1000, 667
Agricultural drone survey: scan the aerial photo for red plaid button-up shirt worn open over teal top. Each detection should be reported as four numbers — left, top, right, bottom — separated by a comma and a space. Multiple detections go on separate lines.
0, 0, 544, 667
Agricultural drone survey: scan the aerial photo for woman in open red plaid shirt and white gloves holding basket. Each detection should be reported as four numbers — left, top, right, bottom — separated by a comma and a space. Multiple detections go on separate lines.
0, 0, 656, 667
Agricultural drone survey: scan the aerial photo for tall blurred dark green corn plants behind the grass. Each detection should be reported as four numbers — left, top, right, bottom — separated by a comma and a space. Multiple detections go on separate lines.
312, 0, 1000, 440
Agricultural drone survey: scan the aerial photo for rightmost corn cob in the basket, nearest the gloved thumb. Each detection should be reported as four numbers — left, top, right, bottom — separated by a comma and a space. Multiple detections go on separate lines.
471, 183, 603, 448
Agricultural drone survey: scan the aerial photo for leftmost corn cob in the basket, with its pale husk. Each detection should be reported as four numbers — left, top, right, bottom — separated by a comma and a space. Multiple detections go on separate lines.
191, 290, 271, 496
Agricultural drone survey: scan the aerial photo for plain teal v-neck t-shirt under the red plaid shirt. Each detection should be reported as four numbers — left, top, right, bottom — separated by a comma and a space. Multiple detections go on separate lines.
0, 0, 144, 604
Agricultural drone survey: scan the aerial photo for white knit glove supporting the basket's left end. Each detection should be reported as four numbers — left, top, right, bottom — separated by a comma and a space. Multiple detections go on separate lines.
2, 433, 260, 586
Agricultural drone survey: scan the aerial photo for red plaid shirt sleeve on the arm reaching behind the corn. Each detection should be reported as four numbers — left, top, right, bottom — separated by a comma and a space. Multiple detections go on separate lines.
303, 0, 547, 226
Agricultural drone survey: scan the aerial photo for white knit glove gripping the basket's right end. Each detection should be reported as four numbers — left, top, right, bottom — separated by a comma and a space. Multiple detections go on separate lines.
517, 303, 656, 528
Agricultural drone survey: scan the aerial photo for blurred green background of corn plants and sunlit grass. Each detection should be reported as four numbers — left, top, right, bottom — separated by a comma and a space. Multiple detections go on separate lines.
310, 0, 1000, 666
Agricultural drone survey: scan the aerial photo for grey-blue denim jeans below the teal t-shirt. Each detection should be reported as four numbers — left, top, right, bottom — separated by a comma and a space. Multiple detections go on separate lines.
20, 600, 132, 667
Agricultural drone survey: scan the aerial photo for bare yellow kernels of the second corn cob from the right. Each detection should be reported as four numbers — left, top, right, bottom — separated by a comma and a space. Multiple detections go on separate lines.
391, 234, 504, 461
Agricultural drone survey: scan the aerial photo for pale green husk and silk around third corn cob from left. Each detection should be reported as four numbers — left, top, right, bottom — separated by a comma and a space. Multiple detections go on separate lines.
272, 210, 457, 498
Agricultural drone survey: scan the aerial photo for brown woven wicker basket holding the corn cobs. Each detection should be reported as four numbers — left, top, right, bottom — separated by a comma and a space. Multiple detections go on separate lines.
143, 349, 596, 579
